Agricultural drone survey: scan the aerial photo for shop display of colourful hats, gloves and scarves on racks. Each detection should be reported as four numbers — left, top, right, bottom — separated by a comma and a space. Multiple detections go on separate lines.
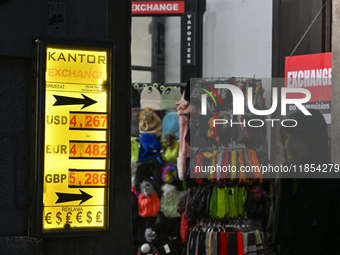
131, 78, 270, 254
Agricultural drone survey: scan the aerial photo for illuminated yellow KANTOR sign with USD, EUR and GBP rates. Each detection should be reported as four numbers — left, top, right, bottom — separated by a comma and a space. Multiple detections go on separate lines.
30, 37, 113, 235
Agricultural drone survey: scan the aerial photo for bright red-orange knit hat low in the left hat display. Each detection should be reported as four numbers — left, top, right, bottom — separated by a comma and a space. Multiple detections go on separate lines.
138, 192, 160, 217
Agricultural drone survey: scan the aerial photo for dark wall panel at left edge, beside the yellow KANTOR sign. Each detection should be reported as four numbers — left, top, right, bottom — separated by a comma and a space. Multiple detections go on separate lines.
0, 57, 32, 236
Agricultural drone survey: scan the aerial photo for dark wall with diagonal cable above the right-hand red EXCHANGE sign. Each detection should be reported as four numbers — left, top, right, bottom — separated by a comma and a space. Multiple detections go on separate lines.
271, 0, 332, 165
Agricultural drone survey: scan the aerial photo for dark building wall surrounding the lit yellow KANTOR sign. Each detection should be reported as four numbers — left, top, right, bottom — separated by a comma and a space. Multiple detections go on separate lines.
0, 0, 132, 254
